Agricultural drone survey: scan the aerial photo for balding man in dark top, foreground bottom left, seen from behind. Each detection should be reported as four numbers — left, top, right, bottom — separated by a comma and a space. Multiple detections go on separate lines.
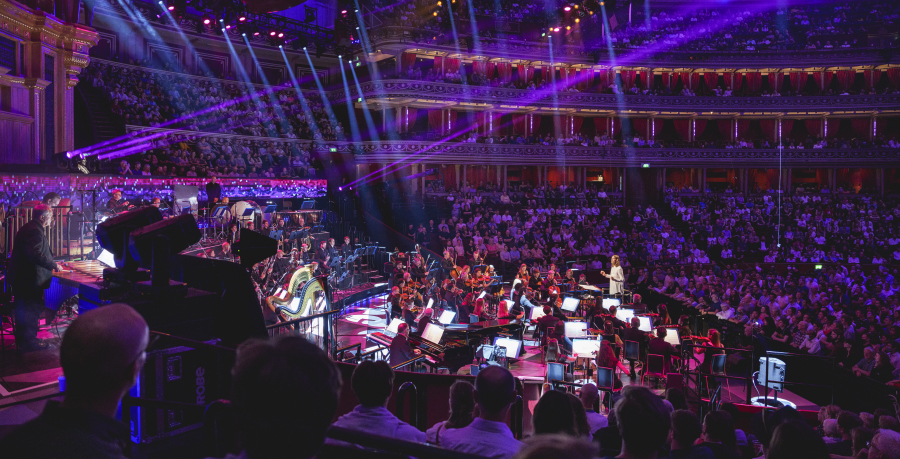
0, 304, 150, 459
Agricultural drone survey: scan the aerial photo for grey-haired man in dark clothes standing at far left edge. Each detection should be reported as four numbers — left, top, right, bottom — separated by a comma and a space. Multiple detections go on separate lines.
9, 204, 61, 352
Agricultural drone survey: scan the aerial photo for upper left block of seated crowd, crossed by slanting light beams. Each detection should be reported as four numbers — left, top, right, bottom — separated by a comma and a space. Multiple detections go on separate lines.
79, 62, 344, 140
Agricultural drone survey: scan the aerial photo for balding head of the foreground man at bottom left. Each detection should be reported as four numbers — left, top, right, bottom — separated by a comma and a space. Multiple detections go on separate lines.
59, 304, 150, 397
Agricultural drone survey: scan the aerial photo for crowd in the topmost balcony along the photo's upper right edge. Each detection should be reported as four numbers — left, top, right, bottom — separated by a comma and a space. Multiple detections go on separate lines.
374, 0, 898, 54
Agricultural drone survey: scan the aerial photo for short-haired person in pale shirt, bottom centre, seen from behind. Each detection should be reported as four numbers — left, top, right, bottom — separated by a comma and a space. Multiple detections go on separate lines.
441, 366, 524, 459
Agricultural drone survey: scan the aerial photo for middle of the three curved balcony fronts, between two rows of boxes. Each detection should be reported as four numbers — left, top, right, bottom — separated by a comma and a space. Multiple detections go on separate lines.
348, 80, 900, 113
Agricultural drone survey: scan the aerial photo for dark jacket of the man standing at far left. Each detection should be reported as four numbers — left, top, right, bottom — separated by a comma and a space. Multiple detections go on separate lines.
10, 221, 56, 293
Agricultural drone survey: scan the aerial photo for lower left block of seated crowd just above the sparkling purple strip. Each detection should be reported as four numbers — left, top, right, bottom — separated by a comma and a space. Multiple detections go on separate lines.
109, 134, 321, 178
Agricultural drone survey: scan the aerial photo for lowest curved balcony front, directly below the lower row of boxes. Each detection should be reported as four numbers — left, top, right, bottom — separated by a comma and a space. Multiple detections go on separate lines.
315, 141, 900, 167
